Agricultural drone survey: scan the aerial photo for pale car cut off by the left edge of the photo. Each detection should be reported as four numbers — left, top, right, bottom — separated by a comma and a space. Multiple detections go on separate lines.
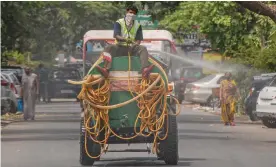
1, 74, 17, 114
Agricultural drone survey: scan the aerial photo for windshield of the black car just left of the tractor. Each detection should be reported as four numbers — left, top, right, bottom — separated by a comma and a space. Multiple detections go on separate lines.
52, 70, 80, 79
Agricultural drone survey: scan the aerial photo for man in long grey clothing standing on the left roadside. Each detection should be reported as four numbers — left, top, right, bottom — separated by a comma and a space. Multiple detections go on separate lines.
21, 67, 39, 121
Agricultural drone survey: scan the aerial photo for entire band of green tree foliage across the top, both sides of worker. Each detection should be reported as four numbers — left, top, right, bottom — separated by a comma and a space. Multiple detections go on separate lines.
1, 1, 276, 73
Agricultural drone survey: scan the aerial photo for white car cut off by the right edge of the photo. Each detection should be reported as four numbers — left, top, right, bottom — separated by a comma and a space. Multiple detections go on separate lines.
256, 77, 276, 128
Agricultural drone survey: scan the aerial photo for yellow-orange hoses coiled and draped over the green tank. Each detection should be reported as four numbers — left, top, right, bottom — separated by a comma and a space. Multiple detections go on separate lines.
68, 55, 180, 159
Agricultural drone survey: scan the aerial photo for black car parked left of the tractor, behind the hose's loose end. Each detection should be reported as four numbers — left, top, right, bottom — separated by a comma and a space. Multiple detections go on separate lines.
49, 67, 82, 98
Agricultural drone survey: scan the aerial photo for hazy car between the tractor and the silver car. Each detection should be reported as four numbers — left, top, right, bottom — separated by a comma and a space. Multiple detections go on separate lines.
175, 66, 204, 103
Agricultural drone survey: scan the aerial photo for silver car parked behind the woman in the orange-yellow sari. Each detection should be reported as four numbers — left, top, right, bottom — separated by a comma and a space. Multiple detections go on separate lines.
184, 73, 224, 104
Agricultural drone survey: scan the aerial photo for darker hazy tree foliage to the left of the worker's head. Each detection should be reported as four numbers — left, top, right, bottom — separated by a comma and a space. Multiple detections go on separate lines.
1, 1, 124, 61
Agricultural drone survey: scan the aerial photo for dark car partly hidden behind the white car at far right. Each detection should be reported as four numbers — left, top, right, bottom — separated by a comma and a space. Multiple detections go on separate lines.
245, 76, 272, 121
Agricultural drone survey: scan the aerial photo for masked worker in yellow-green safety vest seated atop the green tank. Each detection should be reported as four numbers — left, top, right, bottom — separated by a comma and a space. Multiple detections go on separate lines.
97, 6, 153, 77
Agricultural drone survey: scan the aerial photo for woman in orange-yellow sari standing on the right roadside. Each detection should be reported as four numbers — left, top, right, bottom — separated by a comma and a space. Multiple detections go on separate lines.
220, 72, 239, 126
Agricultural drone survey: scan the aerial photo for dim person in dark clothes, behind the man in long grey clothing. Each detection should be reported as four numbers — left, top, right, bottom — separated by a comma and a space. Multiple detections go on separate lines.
38, 64, 50, 102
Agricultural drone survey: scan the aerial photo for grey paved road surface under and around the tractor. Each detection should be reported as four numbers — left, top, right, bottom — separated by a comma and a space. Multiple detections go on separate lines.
1, 102, 276, 167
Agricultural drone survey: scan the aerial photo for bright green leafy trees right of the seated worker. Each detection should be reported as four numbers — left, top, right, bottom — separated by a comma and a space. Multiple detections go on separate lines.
161, 1, 276, 70
